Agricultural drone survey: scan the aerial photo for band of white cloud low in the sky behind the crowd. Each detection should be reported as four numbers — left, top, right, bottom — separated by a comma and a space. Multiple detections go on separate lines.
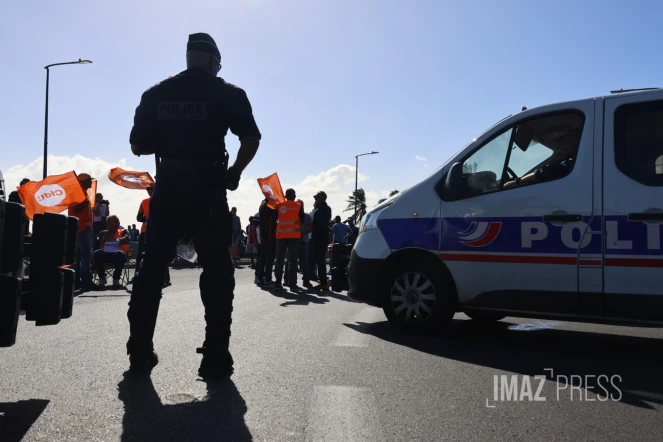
3, 155, 391, 230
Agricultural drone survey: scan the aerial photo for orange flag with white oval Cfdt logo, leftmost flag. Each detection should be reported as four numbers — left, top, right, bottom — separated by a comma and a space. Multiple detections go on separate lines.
18, 172, 87, 220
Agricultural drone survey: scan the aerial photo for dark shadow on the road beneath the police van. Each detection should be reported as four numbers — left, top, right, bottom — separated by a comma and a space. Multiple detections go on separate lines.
345, 320, 663, 409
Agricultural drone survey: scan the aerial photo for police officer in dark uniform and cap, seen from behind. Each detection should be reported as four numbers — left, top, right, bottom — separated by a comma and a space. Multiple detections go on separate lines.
127, 33, 261, 378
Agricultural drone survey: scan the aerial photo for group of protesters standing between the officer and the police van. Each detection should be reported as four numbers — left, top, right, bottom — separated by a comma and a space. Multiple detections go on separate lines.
241, 189, 359, 290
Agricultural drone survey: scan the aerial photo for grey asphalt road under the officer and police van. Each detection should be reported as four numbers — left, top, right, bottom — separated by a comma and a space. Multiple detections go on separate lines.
0, 269, 663, 442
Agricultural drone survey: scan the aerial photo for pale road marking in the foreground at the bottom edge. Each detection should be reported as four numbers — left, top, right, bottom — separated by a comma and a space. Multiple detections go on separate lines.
307, 386, 384, 442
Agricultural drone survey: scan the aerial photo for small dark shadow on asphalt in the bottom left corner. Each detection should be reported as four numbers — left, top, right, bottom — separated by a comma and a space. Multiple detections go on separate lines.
0, 399, 49, 442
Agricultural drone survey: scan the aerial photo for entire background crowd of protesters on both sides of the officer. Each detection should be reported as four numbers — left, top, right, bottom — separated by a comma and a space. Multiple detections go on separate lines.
8, 173, 359, 291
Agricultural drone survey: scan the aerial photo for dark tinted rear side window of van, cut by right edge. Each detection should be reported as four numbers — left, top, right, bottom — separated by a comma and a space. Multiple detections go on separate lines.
615, 100, 663, 186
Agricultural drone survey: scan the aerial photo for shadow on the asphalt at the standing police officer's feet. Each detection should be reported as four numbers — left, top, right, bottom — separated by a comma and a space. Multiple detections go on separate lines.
118, 373, 253, 442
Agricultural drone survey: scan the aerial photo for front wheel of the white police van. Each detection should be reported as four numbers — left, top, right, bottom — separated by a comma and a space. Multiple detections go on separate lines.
382, 260, 458, 333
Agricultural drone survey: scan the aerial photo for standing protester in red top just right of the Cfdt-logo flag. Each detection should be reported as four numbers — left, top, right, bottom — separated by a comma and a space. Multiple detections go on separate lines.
68, 173, 96, 291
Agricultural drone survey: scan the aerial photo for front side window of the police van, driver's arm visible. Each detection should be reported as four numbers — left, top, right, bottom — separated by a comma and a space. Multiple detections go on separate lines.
463, 110, 585, 197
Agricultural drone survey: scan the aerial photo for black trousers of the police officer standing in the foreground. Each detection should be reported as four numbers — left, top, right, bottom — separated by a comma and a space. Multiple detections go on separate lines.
127, 165, 235, 354
